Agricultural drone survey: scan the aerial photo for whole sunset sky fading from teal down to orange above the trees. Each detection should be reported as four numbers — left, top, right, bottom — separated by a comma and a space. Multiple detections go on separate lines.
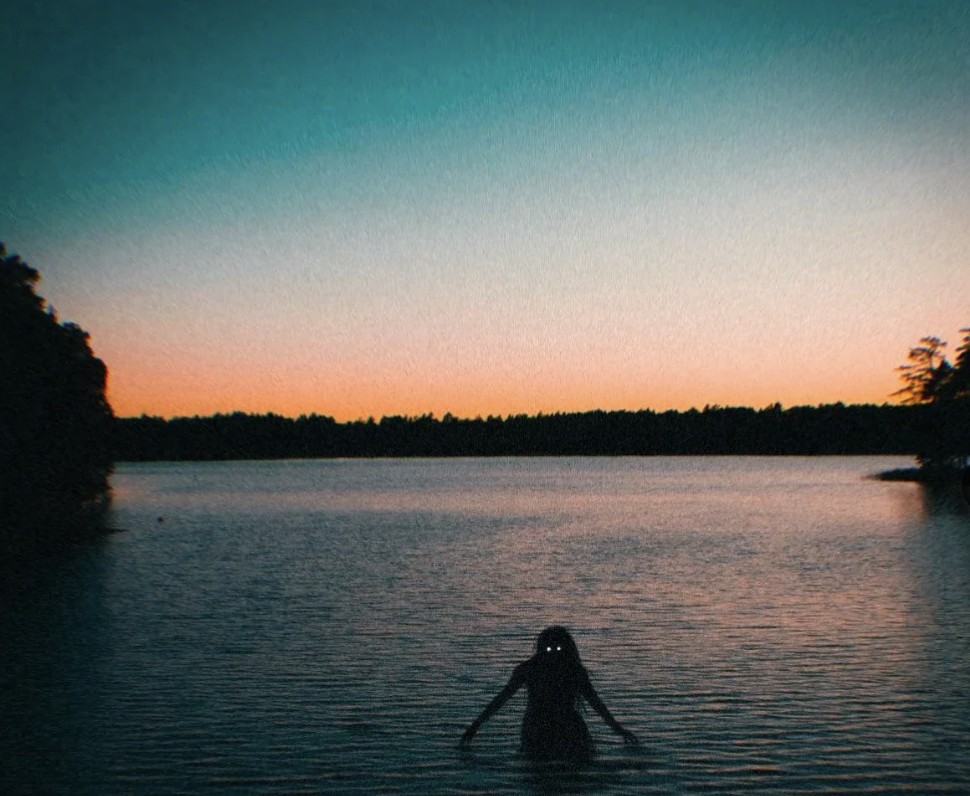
0, 0, 970, 420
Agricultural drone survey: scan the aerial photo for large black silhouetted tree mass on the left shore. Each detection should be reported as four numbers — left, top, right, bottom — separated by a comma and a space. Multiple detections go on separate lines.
0, 243, 113, 552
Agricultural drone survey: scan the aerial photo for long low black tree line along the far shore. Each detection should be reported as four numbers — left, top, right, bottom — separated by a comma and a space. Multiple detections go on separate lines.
111, 403, 929, 461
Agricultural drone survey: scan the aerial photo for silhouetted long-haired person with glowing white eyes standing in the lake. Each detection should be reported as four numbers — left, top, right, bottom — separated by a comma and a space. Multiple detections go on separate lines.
461, 626, 639, 761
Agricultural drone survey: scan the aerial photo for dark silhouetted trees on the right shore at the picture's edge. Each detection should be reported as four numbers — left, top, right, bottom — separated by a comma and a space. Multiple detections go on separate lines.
894, 328, 970, 478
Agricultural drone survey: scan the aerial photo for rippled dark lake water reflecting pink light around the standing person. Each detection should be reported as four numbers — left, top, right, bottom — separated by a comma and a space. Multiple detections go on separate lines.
0, 457, 970, 796
